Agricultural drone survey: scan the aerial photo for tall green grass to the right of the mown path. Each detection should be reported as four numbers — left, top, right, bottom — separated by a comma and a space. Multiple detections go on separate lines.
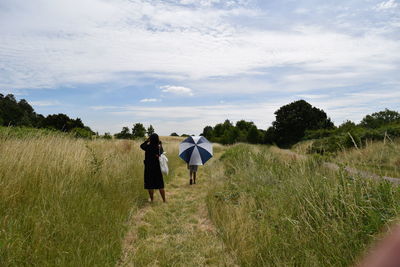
207, 145, 400, 266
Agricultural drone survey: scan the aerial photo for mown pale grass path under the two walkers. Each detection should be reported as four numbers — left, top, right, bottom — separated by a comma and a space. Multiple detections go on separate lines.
118, 153, 237, 266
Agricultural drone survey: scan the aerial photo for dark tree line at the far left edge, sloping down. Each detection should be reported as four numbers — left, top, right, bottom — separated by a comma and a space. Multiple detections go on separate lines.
0, 94, 94, 137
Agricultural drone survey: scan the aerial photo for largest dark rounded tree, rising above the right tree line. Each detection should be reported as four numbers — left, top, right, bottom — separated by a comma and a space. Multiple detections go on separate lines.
269, 100, 334, 147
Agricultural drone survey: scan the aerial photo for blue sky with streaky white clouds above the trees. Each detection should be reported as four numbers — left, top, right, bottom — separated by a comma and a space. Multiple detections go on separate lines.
0, 0, 400, 135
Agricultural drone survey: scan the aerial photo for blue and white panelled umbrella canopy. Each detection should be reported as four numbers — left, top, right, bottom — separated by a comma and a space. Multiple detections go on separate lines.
179, 136, 213, 165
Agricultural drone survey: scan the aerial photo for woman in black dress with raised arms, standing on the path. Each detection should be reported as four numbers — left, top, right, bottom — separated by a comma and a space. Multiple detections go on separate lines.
140, 133, 165, 202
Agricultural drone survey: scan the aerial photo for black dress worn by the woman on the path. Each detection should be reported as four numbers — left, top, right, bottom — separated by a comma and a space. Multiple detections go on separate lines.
140, 142, 164, 189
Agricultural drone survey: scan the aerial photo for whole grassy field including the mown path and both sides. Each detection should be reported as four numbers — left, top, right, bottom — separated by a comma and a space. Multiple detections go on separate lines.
0, 129, 400, 266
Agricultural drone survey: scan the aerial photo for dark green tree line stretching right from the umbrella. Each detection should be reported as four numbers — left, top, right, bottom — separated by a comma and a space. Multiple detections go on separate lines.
202, 100, 400, 148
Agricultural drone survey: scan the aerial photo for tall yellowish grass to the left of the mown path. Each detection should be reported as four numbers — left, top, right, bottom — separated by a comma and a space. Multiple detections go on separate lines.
0, 131, 177, 266
